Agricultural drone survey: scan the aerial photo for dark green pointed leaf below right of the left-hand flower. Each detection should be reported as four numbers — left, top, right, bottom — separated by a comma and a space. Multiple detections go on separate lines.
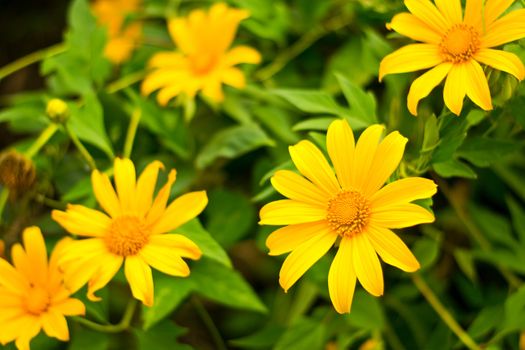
190, 259, 267, 313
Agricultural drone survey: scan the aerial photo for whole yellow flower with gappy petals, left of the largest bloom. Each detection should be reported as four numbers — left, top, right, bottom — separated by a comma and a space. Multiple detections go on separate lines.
52, 158, 208, 306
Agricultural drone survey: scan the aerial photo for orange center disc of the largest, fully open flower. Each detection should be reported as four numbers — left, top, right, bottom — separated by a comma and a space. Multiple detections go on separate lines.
326, 191, 370, 236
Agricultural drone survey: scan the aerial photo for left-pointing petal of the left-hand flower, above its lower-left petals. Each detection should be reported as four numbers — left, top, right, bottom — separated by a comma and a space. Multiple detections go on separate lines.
51, 204, 111, 237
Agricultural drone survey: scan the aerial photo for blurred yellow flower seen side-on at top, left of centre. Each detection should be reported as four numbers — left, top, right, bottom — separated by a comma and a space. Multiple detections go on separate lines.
142, 3, 261, 106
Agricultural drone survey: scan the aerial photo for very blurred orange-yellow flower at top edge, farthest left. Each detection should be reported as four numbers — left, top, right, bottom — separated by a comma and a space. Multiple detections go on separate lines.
92, 0, 142, 64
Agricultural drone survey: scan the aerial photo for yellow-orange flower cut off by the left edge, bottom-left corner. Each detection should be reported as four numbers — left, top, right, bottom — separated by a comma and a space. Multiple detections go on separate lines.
0, 227, 85, 349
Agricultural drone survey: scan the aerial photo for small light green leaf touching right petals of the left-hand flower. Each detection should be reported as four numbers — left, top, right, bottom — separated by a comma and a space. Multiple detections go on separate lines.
175, 219, 232, 267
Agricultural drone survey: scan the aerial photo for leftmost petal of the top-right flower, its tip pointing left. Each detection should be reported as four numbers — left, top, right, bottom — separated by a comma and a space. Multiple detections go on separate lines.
379, 43, 443, 81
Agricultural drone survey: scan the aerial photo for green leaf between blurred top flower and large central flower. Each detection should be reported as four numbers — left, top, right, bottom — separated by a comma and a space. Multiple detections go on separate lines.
195, 124, 274, 169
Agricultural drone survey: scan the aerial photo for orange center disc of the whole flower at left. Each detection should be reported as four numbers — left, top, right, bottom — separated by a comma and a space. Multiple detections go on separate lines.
104, 215, 150, 256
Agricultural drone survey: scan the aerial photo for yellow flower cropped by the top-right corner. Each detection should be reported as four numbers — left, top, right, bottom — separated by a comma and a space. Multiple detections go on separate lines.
379, 0, 525, 115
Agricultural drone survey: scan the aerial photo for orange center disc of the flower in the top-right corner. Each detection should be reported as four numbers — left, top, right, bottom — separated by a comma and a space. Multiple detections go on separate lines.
439, 24, 479, 63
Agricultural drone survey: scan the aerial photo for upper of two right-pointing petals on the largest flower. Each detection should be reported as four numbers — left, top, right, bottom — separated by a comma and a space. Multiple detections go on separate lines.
370, 177, 437, 208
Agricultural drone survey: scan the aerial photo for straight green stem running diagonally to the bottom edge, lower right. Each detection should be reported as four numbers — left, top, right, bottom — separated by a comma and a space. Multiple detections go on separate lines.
412, 273, 481, 350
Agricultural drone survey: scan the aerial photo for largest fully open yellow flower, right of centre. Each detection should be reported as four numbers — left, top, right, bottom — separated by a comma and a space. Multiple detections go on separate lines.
260, 120, 436, 313
